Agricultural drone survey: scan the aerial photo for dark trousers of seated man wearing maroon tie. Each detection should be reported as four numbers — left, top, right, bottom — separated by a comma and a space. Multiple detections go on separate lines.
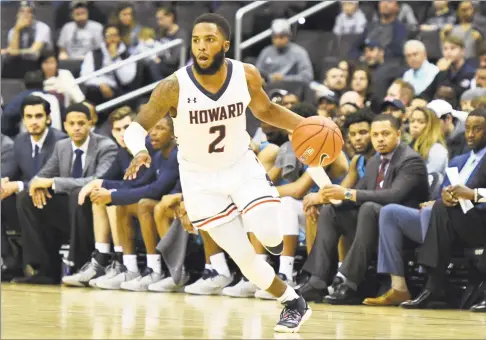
304, 202, 382, 284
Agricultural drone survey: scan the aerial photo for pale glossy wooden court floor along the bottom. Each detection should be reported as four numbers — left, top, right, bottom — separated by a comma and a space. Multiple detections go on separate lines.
1, 284, 486, 339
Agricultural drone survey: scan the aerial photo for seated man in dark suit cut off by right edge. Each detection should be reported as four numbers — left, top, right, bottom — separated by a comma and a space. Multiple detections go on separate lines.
401, 108, 486, 309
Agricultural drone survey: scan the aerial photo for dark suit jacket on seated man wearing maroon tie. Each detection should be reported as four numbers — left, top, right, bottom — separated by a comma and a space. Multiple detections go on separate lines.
355, 143, 429, 208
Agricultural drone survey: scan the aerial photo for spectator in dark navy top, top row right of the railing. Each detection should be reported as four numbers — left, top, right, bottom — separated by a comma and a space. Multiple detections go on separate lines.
350, 0, 407, 59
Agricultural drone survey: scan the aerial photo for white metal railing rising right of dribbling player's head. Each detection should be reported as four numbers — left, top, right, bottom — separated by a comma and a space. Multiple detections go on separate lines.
235, 0, 337, 60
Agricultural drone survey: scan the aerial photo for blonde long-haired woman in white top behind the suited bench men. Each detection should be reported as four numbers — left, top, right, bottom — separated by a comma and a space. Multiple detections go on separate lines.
409, 108, 449, 177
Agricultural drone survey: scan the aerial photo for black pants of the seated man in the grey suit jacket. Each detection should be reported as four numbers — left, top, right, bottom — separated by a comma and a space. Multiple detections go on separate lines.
17, 189, 94, 278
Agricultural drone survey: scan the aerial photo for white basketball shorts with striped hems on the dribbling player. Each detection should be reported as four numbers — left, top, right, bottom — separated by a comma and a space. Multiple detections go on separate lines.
179, 150, 280, 230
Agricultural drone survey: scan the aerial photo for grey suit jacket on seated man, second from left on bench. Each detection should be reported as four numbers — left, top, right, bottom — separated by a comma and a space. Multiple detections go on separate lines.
37, 133, 118, 193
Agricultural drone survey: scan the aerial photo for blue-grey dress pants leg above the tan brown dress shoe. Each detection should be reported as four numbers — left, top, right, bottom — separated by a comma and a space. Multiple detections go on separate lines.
378, 204, 432, 277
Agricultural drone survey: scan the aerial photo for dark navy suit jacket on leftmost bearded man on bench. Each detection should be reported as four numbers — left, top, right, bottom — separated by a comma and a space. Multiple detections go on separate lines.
14, 128, 67, 188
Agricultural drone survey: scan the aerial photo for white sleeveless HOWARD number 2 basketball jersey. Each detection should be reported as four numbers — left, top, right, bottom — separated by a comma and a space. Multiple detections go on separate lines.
174, 59, 251, 171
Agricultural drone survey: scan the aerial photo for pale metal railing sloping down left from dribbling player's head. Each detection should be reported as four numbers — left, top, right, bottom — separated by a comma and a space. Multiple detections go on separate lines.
76, 39, 187, 84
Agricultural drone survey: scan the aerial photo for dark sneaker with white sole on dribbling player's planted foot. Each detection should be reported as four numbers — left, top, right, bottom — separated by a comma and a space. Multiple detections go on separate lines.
273, 296, 312, 333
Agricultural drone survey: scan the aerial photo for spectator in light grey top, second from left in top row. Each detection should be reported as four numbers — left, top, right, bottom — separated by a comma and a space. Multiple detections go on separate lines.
57, 1, 103, 60
